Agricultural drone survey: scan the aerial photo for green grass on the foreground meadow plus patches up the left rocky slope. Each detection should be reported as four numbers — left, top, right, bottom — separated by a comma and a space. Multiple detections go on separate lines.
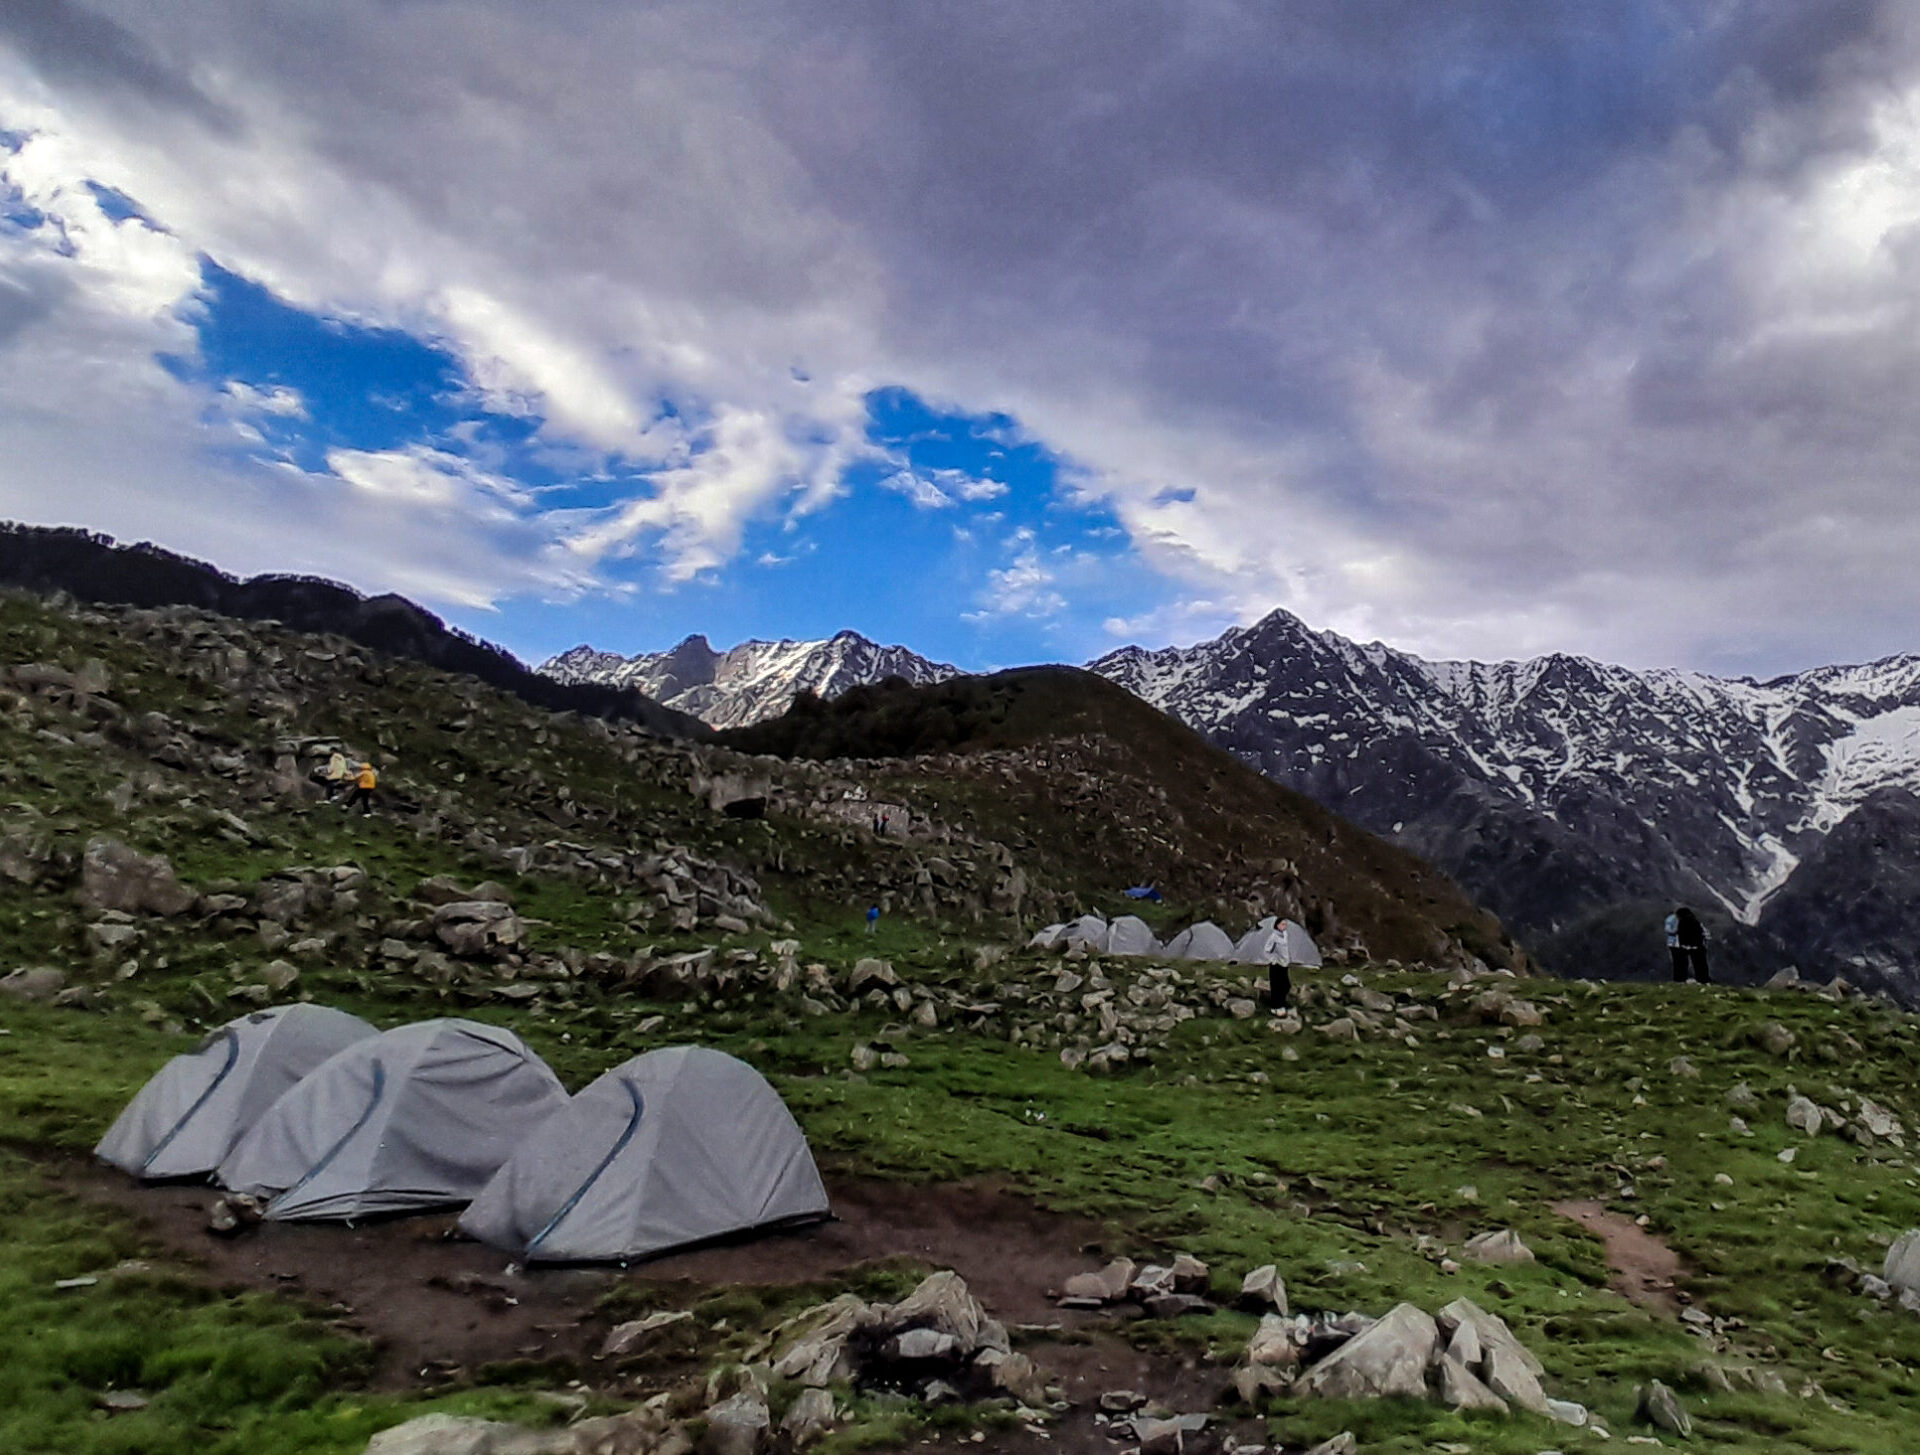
0, 598, 1920, 1455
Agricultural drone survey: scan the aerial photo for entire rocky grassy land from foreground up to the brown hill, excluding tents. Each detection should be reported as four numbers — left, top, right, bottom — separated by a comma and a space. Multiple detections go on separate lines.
18, 579, 1920, 1455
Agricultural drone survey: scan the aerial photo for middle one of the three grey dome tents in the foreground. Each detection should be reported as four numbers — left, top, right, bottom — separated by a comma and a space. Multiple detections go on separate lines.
219, 1019, 566, 1221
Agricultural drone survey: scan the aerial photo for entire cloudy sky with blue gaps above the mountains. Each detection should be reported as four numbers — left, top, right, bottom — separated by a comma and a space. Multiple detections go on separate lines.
0, 0, 1920, 674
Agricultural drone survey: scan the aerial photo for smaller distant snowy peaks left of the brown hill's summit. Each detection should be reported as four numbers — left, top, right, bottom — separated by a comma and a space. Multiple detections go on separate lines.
540, 632, 958, 728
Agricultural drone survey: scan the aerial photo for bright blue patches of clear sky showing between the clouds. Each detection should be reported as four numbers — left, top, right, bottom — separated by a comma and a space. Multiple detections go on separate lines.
153, 264, 1175, 668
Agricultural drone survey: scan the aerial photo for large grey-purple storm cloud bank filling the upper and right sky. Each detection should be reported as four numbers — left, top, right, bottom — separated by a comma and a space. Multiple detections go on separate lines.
0, 0, 1920, 670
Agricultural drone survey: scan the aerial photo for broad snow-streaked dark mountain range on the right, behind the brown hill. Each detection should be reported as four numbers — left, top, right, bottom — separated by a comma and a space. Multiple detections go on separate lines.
1091, 612, 1920, 979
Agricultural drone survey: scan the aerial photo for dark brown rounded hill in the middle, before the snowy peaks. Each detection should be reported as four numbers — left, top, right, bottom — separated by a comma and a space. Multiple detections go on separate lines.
720, 668, 1523, 978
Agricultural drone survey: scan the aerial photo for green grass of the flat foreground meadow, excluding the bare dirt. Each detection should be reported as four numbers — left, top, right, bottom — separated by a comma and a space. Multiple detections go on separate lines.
11, 963, 1920, 1451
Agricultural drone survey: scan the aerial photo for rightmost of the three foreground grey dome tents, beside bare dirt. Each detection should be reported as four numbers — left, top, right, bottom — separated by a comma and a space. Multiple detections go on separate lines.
461, 1046, 829, 1263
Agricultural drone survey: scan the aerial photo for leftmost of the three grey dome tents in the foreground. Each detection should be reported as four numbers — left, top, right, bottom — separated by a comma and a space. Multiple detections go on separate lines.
94, 1006, 378, 1179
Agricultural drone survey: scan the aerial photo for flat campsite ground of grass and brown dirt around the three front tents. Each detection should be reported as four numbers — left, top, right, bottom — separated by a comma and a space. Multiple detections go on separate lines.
11, 944, 1920, 1451
